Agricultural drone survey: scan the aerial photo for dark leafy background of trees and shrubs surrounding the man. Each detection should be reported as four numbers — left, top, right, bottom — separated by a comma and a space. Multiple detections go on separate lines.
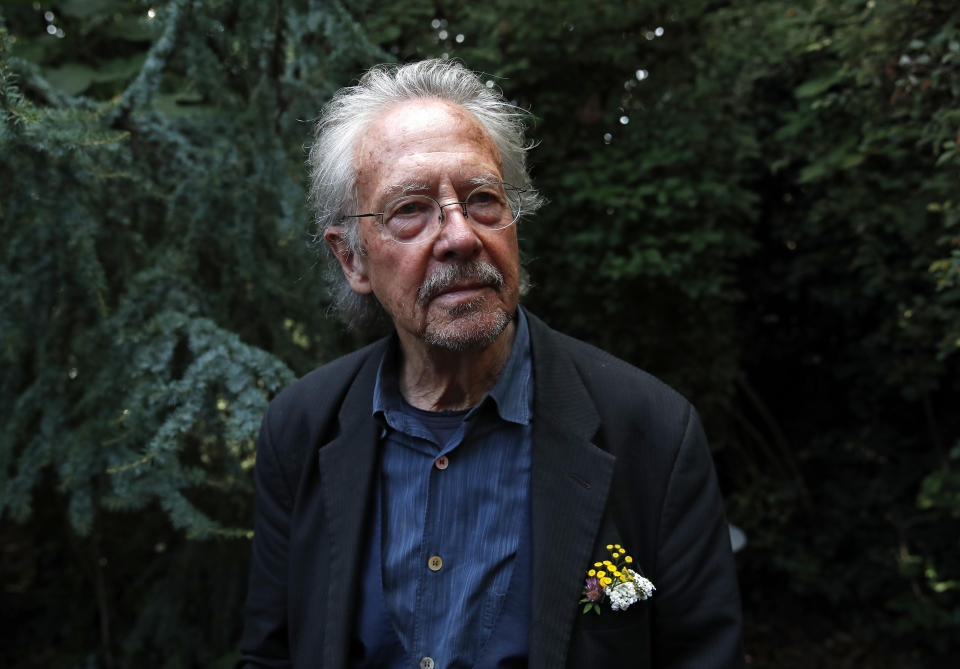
0, 0, 960, 669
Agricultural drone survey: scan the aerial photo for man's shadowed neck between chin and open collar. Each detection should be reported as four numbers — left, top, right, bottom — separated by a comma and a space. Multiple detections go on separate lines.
399, 321, 517, 411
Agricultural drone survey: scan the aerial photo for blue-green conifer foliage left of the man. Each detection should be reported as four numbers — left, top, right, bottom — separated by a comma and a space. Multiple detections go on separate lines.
0, 1, 380, 666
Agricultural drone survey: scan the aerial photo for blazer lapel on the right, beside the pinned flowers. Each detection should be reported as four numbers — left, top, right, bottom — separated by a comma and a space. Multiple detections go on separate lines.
527, 313, 616, 669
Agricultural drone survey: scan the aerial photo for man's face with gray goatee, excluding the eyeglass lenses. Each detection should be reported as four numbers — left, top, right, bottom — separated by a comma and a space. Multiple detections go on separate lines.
341, 100, 520, 349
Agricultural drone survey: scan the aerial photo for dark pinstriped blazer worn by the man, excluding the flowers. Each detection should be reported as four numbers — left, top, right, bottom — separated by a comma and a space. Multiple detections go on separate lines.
238, 312, 742, 669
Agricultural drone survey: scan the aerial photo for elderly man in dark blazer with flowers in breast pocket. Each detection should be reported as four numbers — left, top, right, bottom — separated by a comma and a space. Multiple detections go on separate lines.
239, 60, 741, 669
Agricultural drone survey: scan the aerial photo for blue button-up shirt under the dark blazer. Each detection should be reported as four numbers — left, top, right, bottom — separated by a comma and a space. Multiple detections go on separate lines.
373, 310, 533, 669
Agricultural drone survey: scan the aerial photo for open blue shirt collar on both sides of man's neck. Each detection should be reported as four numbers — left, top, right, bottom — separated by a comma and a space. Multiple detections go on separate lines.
373, 308, 533, 425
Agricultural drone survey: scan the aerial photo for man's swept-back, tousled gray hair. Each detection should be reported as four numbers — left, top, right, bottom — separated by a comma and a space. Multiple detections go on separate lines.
308, 59, 543, 328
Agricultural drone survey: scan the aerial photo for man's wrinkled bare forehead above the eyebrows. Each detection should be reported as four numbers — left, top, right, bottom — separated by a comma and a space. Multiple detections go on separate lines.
354, 99, 503, 194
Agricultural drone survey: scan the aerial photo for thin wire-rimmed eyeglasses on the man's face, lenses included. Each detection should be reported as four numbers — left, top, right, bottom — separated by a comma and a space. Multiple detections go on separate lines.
345, 182, 526, 244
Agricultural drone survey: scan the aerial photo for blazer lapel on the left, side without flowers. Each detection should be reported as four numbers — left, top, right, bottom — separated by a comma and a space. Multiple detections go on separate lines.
318, 355, 381, 668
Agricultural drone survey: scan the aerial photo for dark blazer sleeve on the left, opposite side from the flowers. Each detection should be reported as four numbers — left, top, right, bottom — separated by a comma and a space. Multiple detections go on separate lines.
236, 412, 293, 669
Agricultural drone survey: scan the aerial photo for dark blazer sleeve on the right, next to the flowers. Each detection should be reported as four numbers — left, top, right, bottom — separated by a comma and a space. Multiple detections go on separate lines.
652, 407, 743, 669
